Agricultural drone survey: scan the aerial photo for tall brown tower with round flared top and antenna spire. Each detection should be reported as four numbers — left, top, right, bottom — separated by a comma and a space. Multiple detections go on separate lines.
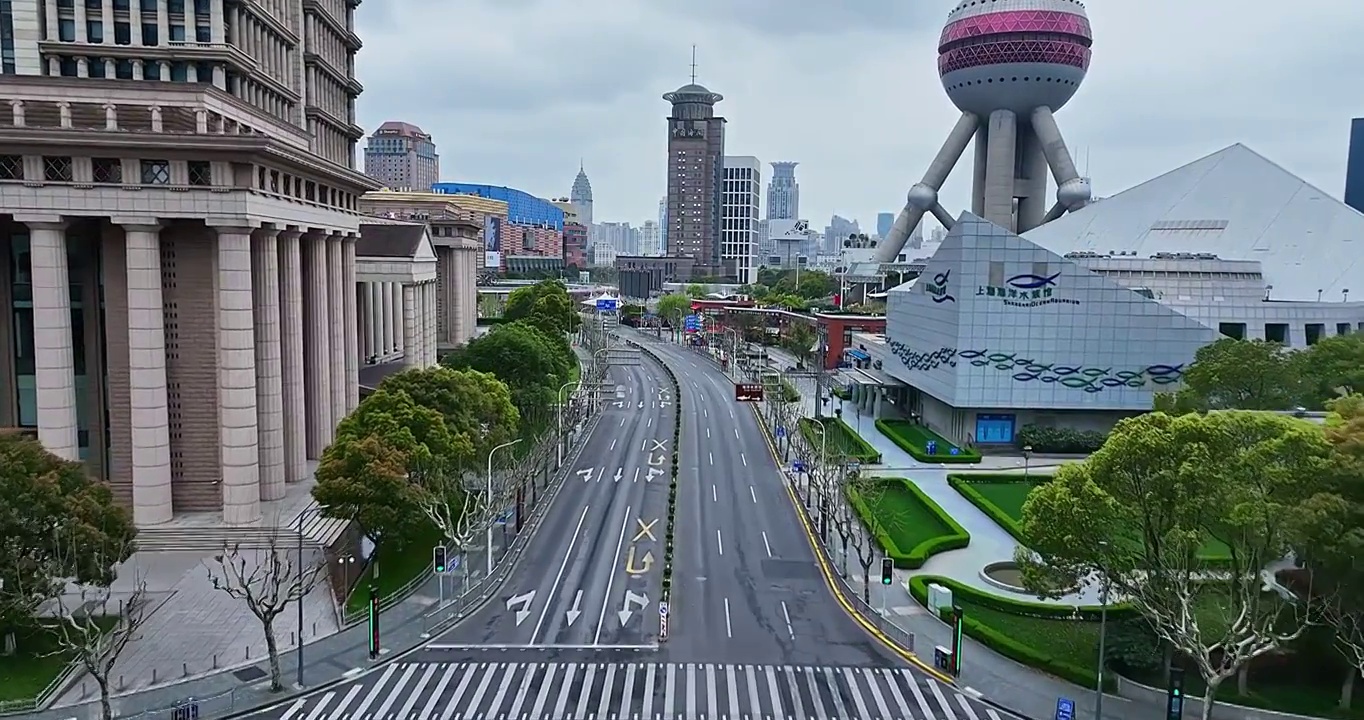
663, 76, 726, 274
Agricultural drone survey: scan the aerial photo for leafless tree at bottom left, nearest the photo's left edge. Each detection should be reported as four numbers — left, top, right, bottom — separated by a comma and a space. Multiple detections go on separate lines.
39, 545, 147, 720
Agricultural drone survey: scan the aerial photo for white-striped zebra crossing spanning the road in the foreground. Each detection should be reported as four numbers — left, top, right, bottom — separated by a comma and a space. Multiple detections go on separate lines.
270, 663, 1012, 720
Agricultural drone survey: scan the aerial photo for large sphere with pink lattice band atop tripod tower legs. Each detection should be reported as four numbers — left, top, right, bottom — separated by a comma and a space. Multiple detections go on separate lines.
938, 0, 1094, 116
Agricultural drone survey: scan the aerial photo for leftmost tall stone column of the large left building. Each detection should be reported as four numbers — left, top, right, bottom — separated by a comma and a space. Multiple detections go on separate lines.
23, 215, 80, 461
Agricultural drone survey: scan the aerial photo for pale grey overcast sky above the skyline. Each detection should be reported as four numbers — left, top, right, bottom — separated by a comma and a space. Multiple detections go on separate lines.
357, 0, 1364, 229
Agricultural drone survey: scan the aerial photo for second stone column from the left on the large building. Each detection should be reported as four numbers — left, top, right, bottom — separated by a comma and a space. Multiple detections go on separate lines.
123, 225, 175, 528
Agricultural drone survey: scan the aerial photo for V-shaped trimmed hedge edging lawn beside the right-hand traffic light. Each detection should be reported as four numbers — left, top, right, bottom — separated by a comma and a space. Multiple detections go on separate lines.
908, 575, 1138, 690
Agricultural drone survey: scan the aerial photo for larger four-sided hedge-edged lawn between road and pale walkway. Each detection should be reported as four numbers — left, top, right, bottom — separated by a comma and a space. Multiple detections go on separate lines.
847, 477, 971, 570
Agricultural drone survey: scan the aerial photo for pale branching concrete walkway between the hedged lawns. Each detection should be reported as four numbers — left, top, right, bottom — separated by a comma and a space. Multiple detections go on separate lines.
752, 348, 1099, 605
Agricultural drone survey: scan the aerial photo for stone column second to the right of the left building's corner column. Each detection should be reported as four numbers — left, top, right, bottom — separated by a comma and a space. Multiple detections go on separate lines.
276, 230, 308, 483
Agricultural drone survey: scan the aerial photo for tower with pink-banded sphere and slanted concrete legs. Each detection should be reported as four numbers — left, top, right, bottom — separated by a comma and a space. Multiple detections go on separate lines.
877, 0, 1093, 263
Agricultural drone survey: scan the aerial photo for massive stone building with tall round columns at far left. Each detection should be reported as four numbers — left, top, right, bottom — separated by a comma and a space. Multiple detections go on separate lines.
0, 0, 395, 526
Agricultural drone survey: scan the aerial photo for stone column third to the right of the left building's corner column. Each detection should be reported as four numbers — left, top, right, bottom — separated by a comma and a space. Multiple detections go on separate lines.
303, 233, 334, 460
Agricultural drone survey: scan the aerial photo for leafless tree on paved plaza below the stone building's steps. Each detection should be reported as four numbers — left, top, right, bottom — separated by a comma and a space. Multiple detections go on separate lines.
207, 533, 326, 693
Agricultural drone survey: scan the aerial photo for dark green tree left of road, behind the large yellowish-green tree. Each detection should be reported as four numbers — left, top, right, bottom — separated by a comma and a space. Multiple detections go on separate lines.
450, 322, 573, 430
